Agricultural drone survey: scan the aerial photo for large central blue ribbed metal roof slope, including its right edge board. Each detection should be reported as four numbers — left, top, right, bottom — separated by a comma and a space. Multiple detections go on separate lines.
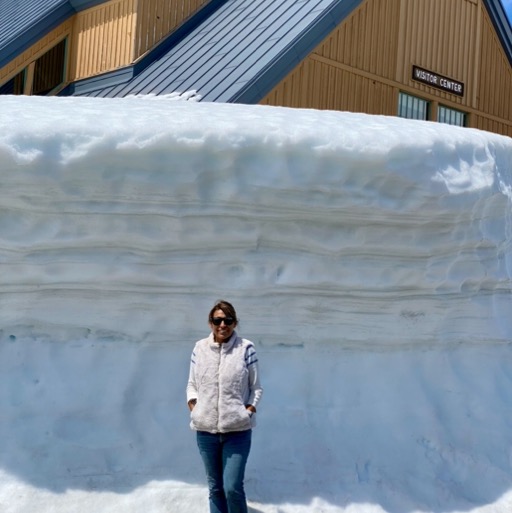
67, 0, 363, 103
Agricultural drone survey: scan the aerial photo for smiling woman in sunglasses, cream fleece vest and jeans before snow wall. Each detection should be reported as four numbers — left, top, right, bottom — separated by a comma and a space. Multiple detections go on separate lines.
187, 301, 262, 513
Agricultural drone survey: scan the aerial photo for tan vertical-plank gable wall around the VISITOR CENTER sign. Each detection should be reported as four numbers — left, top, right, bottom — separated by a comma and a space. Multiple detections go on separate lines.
260, 0, 512, 136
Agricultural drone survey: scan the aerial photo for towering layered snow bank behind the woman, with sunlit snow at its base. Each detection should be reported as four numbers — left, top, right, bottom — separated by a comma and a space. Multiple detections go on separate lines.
0, 97, 512, 513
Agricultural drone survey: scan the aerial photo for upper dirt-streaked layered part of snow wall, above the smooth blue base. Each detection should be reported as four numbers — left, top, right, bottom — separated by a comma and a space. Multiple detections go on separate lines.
0, 98, 512, 347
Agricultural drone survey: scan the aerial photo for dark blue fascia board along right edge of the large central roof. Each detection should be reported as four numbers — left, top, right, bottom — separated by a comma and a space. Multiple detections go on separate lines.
226, 0, 364, 104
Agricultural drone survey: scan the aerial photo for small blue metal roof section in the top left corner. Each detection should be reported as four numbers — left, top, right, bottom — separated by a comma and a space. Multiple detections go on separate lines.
0, 0, 106, 68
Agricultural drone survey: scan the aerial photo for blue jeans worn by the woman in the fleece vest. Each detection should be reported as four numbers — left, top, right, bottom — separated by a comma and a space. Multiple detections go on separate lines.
197, 429, 252, 513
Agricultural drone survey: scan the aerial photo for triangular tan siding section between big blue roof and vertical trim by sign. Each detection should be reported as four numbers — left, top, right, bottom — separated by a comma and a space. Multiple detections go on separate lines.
260, 0, 400, 115
